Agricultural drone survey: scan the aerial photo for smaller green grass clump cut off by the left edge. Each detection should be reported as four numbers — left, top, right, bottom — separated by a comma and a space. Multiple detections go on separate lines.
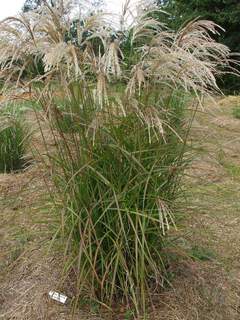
0, 107, 29, 172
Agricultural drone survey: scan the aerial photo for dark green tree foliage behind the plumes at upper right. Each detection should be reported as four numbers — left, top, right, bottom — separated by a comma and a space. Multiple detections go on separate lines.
158, 0, 240, 92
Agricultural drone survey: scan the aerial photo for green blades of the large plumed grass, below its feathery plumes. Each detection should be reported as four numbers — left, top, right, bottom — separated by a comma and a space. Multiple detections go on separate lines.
50, 86, 187, 312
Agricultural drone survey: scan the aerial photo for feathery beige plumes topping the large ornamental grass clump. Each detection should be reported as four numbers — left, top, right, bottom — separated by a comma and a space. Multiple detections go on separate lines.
0, 1, 233, 99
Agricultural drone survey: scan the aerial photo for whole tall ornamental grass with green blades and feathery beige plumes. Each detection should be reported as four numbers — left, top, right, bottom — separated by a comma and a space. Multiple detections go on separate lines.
0, 1, 236, 314
